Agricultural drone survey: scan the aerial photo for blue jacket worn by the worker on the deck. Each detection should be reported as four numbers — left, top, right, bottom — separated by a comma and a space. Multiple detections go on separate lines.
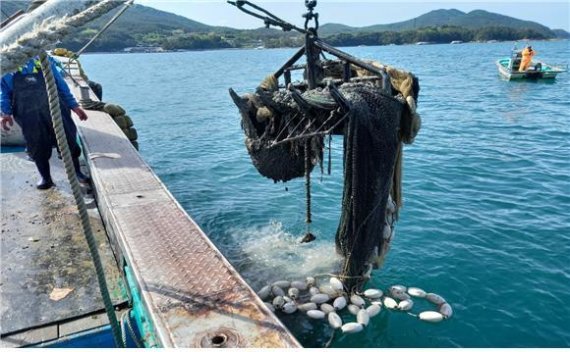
0, 57, 79, 115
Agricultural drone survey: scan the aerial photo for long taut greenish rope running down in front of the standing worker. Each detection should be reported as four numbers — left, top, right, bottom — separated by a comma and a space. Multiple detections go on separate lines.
40, 52, 125, 347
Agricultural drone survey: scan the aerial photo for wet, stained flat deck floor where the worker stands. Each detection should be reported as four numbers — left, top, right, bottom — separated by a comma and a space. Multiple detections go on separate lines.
0, 152, 127, 336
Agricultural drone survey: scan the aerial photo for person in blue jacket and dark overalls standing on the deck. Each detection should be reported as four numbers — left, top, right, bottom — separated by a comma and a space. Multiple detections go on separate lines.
0, 57, 89, 189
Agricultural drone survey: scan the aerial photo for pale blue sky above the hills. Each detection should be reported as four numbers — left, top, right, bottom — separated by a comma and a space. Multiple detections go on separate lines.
139, 0, 570, 31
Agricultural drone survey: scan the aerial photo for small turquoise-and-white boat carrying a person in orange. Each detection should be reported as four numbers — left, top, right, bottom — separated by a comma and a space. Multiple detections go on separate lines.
497, 50, 567, 81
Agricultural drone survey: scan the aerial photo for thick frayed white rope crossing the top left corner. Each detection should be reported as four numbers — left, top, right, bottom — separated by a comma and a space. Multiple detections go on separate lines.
0, 0, 125, 75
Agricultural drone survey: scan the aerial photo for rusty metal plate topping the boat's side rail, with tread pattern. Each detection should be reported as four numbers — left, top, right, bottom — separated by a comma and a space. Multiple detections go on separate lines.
65, 79, 301, 347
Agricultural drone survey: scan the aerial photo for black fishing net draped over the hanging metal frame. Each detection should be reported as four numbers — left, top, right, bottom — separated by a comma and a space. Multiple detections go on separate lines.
230, 61, 419, 289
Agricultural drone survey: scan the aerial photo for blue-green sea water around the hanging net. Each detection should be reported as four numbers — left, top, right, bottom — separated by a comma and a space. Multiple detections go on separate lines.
82, 41, 570, 347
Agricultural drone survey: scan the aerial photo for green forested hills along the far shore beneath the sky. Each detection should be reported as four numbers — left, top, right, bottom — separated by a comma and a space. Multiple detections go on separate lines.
1, 0, 569, 51
